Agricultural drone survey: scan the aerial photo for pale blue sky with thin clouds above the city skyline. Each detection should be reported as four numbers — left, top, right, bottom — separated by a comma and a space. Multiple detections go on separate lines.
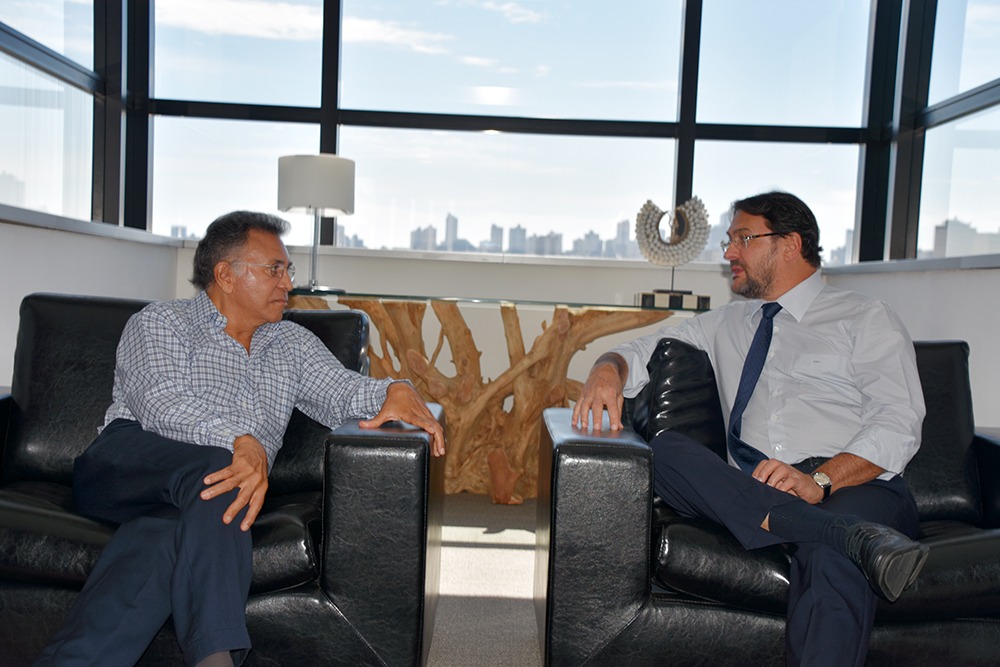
0, 0, 1000, 260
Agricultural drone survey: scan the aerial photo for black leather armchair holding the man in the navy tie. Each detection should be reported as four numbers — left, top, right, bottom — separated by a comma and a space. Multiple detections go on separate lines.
535, 339, 1000, 667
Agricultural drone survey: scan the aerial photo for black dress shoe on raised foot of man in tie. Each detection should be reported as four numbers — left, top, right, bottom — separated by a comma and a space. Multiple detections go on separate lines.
845, 523, 929, 602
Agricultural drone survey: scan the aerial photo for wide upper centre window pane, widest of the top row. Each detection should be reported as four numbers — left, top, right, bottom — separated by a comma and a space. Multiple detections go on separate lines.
341, 0, 683, 121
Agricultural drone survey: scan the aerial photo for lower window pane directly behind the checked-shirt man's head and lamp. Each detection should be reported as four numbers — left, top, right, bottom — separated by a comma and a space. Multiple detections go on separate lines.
152, 117, 319, 245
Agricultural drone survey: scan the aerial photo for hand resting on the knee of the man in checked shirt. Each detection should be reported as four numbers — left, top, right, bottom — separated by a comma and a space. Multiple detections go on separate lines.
201, 435, 267, 532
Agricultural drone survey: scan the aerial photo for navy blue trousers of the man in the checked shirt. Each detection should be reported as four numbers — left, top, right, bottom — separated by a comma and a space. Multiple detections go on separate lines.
35, 419, 252, 667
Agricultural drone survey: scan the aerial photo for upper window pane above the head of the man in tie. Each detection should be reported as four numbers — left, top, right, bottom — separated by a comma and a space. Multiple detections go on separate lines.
698, 0, 870, 127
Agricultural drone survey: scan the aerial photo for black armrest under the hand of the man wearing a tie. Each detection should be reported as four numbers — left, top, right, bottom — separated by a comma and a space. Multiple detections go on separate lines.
534, 408, 653, 665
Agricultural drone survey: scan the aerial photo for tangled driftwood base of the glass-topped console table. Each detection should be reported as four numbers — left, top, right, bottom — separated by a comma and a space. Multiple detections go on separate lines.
289, 296, 672, 504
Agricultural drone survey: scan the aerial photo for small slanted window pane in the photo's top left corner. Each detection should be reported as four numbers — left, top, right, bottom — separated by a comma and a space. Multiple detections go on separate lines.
0, 0, 94, 69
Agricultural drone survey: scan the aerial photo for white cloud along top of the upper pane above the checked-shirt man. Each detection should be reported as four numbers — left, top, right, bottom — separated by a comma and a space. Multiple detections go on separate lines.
156, 0, 323, 40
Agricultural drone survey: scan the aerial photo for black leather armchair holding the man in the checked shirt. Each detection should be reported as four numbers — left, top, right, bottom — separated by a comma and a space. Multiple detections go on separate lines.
0, 294, 444, 666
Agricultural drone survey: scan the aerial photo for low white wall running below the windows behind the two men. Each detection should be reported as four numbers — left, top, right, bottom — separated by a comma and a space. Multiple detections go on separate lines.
0, 222, 1000, 427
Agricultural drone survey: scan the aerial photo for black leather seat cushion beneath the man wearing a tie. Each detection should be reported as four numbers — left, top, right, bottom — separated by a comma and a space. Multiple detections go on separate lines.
654, 508, 1000, 622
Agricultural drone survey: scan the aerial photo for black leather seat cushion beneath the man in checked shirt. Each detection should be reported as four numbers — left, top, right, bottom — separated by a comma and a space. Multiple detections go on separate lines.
0, 482, 320, 593
